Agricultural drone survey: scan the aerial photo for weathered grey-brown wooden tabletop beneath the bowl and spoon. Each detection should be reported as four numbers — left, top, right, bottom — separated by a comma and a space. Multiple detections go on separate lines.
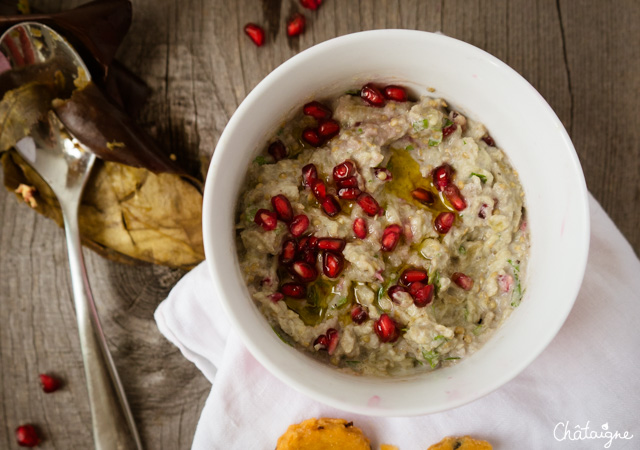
0, 0, 640, 450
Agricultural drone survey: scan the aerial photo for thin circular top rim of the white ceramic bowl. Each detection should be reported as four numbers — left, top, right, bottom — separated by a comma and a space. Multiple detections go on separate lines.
202, 29, 590, 416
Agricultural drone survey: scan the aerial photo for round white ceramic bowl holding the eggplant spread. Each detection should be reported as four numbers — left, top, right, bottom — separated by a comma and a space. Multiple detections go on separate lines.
203, 30, 589, 416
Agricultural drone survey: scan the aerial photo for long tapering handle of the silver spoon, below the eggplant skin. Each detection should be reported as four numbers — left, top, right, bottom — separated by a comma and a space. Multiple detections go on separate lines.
61, 202, 142, 450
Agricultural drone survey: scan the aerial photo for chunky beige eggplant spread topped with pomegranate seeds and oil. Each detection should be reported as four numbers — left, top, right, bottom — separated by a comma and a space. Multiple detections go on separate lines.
236, 84, 529, 376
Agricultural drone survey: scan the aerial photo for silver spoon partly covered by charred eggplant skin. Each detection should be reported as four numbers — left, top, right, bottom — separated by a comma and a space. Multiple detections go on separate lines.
0, 22, 142, 450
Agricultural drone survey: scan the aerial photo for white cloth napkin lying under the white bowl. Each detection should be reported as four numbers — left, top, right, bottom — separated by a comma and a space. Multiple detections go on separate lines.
155, 197, 640, 450
